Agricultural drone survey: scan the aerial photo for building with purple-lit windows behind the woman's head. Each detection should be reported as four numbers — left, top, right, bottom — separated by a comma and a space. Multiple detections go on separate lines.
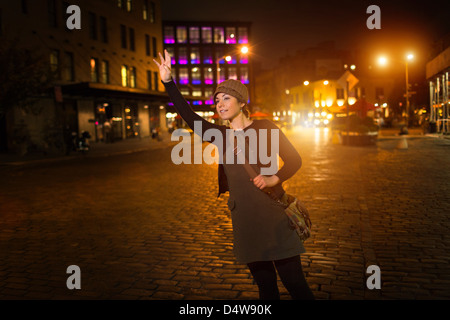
163, 21, 253, 125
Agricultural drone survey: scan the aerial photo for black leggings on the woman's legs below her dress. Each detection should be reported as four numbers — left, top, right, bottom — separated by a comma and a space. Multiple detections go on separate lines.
248, 256, 314, 300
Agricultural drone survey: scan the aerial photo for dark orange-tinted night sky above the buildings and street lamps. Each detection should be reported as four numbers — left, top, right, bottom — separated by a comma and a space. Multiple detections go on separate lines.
161, 0, 450, 67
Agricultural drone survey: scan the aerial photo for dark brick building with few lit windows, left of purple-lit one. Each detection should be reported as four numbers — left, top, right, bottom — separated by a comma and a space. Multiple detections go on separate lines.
0, 0, 168, 154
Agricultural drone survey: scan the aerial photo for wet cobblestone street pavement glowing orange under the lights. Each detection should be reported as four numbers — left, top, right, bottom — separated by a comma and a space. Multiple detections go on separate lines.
0, 129, 450, 300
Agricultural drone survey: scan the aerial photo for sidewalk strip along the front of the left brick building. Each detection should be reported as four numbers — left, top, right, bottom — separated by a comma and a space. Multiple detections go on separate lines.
0, 132, 178, 166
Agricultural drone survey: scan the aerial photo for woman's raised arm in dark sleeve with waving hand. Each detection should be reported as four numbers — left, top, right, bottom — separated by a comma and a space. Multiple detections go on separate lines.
153, 50, 223, 136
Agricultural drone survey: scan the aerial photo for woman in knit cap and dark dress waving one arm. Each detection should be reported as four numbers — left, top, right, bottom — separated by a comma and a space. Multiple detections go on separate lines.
154, 51, 314, 300
